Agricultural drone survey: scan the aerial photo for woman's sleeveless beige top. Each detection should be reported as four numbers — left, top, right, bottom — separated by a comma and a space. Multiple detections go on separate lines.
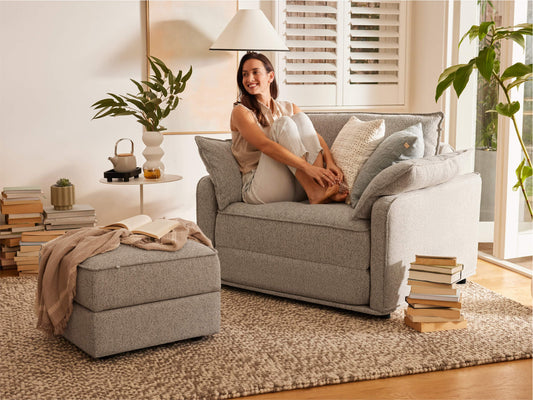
231, 99, 294, 175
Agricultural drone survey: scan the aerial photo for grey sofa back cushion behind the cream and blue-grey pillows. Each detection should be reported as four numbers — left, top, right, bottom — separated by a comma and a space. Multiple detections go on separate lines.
307, 112, 444, 157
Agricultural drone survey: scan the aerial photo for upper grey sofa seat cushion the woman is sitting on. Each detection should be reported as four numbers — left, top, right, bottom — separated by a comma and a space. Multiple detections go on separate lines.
215, 202, 370, 270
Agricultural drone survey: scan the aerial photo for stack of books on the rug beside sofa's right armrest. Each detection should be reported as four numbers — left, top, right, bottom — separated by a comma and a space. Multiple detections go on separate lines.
404, 255, 466, 332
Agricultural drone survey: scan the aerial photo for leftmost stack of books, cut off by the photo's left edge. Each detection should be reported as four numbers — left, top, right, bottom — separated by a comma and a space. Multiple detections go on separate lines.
0, 186, 44, 269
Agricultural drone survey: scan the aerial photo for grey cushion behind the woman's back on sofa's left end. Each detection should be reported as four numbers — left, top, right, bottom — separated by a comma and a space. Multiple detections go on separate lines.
194, 136, 242, 210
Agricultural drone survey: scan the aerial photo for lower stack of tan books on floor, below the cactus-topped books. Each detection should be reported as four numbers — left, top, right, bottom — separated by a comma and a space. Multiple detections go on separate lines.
15, 231, 65, 275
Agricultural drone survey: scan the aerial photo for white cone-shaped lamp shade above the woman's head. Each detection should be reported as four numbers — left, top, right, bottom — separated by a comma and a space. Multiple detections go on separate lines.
210, 9, 289, 51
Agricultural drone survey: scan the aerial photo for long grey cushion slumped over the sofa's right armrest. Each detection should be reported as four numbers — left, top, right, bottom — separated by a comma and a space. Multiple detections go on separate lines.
354, 149, 473, 219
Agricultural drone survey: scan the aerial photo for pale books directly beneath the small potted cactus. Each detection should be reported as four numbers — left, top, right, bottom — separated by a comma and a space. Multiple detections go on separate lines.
44, 204, 96, 231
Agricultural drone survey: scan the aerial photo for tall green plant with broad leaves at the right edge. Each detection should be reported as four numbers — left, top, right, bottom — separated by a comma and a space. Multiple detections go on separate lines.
435, 1, 533, 218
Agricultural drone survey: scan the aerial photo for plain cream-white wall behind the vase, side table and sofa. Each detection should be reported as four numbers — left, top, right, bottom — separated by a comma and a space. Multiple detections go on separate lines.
0, 0, 456, 224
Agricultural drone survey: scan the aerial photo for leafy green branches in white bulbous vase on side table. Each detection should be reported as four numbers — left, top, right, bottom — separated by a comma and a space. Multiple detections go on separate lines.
91, 56, 192, 178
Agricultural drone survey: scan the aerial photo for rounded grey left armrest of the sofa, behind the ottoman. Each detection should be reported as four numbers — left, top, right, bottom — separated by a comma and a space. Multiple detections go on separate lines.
196, 176, 218, 246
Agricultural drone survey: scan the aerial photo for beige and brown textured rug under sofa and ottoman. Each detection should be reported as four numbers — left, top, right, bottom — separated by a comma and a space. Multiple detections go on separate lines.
0, 278, 532, 400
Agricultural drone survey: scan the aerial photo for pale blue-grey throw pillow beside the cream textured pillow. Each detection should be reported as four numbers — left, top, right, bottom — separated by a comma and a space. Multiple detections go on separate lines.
350, 123, 424, 207
